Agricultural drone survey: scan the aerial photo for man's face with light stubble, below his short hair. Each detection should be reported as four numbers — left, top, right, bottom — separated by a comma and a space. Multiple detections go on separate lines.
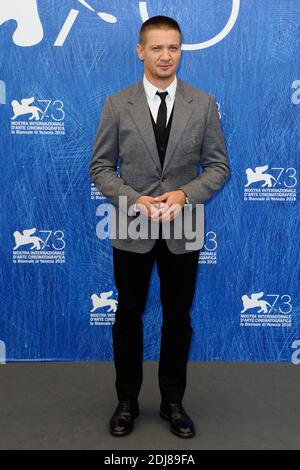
137, 29, 181, 80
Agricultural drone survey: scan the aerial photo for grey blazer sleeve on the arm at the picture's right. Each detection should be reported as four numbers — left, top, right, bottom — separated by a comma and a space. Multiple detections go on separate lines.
179, 95, 230, 204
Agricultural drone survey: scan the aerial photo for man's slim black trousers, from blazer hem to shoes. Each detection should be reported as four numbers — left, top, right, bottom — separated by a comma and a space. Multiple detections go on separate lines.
112, 230, 200, 403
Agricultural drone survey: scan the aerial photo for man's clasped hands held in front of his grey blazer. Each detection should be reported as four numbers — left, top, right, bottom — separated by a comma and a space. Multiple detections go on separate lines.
136, 189, 186, 222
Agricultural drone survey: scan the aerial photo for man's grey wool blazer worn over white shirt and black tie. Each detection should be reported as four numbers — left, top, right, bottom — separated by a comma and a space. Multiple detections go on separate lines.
90, 79, 230, 254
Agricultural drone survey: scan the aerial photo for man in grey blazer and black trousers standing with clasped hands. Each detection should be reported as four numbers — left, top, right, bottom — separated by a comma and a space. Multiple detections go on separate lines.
90, 16, 230, 438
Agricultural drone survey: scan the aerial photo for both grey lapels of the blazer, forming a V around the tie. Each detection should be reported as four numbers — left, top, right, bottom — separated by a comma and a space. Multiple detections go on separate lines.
128, 78, 193, 172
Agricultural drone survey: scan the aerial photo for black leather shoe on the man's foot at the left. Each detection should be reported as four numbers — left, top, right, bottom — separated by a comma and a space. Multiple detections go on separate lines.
109, 399, 139, 436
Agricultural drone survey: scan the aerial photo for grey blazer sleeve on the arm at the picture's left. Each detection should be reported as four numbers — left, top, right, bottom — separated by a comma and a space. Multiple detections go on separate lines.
90, 97, 141, 214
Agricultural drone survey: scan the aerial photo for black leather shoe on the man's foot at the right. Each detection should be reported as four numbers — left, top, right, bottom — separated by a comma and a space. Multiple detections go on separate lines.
160, 403, 195, 437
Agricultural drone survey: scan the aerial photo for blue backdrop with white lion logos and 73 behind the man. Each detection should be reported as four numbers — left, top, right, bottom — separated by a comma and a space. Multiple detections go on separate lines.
0, 0, 300, 362
